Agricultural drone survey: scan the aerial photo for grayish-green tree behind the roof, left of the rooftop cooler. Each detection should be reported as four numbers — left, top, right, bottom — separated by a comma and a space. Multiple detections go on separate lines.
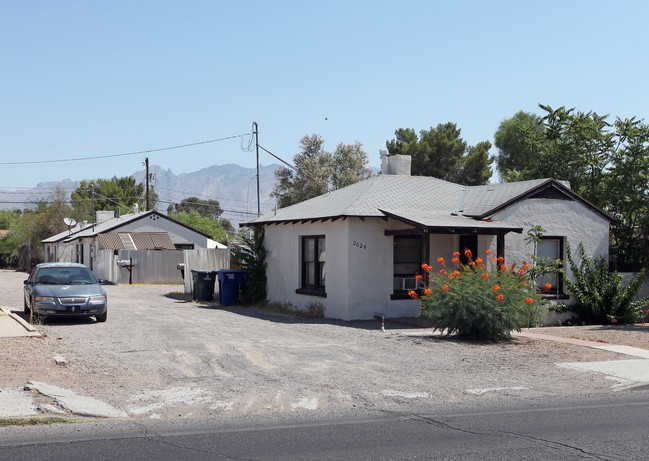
271, 134, 370, 208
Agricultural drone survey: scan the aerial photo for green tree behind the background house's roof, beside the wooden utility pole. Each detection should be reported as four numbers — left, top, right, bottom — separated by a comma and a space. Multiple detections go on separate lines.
70, 176, 158, 221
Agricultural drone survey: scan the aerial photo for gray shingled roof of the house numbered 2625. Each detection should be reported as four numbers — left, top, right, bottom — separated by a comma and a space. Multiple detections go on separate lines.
246, 174, 612, 232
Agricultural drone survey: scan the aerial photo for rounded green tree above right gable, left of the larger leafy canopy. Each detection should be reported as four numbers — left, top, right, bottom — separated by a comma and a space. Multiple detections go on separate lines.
494, 110, 545, 178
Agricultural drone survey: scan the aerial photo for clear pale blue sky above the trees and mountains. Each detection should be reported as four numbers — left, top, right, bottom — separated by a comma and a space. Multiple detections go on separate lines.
0, 0, 649, 188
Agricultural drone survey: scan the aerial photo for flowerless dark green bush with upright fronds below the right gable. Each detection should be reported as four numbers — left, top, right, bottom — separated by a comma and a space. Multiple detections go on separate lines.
562, 243, 649, 325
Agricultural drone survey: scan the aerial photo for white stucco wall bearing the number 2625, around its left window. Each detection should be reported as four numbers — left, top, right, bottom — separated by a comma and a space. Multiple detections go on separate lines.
264, 218, 496, 320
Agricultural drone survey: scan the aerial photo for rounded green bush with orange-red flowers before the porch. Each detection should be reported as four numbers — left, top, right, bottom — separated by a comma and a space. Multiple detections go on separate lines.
410, 250, 541, 340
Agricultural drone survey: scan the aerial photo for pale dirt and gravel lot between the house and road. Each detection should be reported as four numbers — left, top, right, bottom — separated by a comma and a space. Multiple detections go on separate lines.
0, 271, 649, 418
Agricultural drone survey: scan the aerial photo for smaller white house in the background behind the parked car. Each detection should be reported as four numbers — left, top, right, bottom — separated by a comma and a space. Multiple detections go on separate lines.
41, 210, 226, 269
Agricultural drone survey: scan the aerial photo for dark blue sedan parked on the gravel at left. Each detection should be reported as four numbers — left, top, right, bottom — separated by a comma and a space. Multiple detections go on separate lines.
24, 263, 108, 322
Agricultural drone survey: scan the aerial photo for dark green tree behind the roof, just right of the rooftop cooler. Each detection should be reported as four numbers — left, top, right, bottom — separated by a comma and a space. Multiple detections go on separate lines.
386, 122, 493, 185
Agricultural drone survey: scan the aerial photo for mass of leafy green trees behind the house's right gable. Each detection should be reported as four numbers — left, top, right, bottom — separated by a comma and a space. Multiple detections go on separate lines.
496, 104, 649, 269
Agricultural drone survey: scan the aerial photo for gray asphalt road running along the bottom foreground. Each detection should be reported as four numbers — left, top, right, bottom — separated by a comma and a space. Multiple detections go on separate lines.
0, 399, 649, 461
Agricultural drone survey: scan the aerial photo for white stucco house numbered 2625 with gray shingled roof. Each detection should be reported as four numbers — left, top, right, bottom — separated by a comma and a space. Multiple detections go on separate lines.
247, 155, 613, 320
